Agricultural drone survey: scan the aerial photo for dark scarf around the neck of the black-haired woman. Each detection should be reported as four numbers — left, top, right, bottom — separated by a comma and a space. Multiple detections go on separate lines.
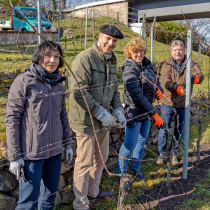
34, 64, 66, 85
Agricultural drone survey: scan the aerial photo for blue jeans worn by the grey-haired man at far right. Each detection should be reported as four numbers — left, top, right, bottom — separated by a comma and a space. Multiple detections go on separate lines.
158, 104, 185, 155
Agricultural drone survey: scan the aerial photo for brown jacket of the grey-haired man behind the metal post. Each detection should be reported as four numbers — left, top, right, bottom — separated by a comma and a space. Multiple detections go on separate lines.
161, 56, 204, 108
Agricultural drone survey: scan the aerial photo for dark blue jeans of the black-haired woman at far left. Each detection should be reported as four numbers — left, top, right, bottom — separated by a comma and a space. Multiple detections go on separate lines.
16, 154, 62, 210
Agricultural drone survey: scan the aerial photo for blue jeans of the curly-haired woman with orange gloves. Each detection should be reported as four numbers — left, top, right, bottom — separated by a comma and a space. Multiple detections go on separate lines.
117, 120, 151, 174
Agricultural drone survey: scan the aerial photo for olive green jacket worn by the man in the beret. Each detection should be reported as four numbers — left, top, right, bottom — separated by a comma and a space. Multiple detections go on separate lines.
69, 44, 122, 133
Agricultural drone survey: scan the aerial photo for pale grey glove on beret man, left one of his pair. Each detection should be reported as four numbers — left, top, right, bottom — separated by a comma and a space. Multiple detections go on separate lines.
95, 107, 117, 127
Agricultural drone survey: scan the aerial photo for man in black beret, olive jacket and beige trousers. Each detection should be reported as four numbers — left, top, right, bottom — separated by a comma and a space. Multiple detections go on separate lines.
69, 25, 126, 210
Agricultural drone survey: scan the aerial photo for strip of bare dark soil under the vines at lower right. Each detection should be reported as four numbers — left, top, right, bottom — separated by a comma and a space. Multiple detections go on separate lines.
131, 143, 210, 209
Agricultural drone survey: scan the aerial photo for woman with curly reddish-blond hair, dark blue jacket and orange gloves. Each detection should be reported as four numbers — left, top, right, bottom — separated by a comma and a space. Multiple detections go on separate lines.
117, 38, 163, 182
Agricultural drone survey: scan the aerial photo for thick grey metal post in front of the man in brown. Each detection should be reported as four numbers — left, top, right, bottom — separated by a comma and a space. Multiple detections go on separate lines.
183, 30, 192, 179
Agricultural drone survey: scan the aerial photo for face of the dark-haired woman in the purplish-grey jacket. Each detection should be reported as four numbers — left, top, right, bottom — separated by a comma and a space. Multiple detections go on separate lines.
40, 49, 60, 73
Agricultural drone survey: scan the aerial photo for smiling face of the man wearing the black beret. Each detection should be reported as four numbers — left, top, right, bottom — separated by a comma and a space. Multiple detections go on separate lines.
99, 33, 118, 54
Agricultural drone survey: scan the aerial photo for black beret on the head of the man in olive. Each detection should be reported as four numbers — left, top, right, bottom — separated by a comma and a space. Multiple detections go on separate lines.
99, 24, 124, 39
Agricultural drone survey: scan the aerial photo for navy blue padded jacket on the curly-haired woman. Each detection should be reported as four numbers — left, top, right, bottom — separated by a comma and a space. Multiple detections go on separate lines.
122, 57, 163, 126
